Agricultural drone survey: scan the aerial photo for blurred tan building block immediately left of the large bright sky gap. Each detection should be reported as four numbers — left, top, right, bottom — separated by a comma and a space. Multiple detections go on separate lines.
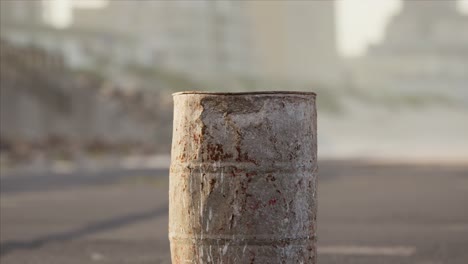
247, 1, 338, 84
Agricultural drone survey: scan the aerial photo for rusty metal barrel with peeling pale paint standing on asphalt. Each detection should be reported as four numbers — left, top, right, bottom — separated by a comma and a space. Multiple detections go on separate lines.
169, 92, 317, 264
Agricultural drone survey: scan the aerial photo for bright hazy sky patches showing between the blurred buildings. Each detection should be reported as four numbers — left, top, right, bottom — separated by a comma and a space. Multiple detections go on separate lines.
47, 0, 468, 56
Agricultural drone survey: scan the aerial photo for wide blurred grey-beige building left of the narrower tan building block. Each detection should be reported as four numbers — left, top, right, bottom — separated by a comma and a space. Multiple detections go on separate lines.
73, 1, 251, 79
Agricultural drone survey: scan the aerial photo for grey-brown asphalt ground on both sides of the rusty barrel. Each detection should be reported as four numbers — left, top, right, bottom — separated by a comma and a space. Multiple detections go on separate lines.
0, 161, 468, 264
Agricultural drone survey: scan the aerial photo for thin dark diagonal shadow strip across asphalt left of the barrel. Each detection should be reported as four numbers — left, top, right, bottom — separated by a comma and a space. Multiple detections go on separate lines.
0, 206, 168, 256
